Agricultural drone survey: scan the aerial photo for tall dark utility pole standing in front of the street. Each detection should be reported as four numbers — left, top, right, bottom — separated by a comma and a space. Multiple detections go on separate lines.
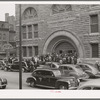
19, 4, 22, 89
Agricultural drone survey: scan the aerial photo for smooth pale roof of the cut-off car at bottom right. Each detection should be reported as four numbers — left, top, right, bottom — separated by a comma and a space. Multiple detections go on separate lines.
78, 79, 100, 89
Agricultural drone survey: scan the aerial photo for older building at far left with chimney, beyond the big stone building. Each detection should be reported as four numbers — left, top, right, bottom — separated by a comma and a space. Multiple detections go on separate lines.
0, 13, 16, 59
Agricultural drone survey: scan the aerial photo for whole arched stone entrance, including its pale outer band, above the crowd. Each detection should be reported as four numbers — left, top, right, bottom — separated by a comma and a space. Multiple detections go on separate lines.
43, 31, 84, 58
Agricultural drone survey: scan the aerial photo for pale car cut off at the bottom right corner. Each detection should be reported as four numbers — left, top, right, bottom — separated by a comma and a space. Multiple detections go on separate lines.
70, 79, 100, 90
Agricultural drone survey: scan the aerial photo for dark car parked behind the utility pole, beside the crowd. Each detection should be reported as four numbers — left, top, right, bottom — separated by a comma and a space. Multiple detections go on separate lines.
4, 61, 30, 72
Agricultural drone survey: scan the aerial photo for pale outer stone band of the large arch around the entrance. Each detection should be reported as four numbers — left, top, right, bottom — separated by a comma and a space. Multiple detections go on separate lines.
43, 31, 84, 58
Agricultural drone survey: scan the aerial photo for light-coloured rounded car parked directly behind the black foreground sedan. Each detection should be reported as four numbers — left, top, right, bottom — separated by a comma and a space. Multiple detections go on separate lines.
59, 64, 89, 80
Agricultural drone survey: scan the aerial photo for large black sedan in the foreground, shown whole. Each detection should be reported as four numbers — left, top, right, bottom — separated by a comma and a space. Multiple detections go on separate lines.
26, 69, 80, 89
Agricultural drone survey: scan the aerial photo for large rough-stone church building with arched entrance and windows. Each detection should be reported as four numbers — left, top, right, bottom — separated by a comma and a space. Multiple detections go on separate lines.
16, 4, 100, 60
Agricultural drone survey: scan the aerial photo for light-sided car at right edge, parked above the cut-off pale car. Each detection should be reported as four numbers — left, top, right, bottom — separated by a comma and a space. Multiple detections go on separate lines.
78, 63, 100, 78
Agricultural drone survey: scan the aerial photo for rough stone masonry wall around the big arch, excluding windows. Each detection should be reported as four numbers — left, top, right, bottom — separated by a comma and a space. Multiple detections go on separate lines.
16, 4, 100, 58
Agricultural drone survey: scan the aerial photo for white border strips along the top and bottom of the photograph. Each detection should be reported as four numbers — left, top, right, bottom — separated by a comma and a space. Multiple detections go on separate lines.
0, 0, 100, 100
